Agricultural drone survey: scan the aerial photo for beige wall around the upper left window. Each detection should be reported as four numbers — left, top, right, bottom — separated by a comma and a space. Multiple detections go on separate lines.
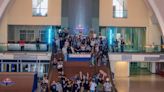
0, 0, 61, 43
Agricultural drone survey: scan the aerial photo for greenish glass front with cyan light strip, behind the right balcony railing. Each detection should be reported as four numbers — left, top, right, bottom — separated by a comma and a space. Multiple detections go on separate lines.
107, 27, 146, 52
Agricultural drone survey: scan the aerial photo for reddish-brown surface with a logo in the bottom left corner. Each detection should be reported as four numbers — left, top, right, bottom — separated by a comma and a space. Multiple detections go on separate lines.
0, 72, 34, 92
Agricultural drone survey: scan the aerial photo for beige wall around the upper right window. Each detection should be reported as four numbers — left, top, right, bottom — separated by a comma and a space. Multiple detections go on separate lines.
100, 0, 148, 27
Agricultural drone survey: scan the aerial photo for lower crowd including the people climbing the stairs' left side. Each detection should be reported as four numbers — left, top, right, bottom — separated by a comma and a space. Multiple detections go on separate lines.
50, 58, 112, 92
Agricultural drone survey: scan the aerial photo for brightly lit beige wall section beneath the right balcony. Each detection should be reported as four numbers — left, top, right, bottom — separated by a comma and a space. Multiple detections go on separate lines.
114, 61, 129, 77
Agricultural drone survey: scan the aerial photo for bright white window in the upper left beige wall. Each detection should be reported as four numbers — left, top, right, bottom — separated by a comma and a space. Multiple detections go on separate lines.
32, 0, 48, 16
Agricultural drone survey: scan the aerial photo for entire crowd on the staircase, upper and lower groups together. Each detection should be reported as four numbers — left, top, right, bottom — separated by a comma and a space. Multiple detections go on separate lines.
40, 30, 115, 92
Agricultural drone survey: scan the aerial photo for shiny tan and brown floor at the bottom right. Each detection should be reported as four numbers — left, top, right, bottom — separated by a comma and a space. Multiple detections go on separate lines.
115, 75, 164, 92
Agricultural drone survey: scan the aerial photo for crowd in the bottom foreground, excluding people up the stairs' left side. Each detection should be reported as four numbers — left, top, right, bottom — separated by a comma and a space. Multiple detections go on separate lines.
50, 72, 112, 92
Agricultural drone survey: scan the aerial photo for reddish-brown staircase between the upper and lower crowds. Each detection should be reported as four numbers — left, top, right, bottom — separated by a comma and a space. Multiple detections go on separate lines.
48, 52, 117, 92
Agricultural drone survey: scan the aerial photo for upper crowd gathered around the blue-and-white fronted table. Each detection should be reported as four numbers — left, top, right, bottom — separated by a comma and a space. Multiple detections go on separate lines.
52, 31, 108, 65
